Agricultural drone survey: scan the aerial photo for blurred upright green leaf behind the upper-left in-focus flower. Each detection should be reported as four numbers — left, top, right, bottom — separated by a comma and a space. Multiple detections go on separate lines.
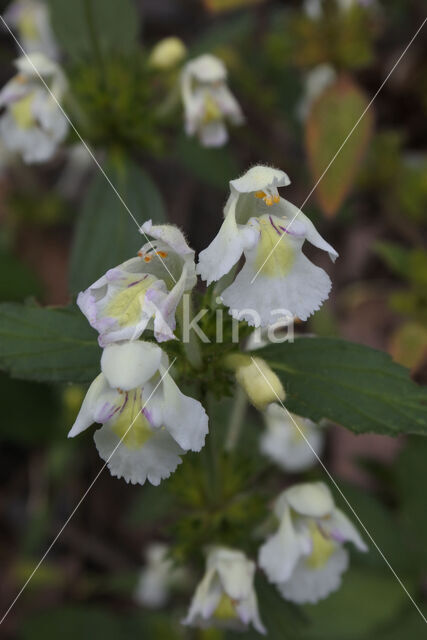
70, 161, 165, 293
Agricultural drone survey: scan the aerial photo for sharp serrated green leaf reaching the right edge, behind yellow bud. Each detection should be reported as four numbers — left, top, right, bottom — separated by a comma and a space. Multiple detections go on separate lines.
256, 338, 427, 435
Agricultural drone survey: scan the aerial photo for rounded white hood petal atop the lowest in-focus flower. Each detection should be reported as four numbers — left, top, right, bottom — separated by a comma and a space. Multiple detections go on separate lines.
101, 341, 162, 391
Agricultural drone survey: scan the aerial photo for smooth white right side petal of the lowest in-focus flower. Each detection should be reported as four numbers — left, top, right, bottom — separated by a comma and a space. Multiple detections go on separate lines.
143, 367, 208, 451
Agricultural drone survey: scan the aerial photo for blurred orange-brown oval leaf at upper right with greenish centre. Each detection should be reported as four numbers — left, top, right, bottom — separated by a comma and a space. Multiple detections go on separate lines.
305, 76, 373, 217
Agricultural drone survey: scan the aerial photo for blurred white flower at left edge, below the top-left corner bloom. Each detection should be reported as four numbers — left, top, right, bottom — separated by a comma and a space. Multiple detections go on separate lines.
0, 53, 68, 163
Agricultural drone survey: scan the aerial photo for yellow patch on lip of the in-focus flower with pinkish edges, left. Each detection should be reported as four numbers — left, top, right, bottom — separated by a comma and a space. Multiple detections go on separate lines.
104, 274, 156, 327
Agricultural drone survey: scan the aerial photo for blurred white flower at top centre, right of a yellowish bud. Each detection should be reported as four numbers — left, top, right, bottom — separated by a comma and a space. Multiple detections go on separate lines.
181, 54, 244, 147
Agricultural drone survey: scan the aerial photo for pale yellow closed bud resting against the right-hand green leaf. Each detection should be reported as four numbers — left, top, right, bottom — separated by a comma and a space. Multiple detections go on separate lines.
226, 354, 286, 410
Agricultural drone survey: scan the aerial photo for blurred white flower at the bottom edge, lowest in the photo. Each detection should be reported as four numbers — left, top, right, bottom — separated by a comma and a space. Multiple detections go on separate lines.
183, 547, 266, 633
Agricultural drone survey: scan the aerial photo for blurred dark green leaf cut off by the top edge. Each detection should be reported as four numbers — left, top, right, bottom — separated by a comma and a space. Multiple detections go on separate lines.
47, 0, 139, 60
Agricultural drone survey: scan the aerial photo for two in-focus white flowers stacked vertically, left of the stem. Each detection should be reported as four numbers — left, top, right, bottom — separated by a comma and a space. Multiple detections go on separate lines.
69, 221, 208, 485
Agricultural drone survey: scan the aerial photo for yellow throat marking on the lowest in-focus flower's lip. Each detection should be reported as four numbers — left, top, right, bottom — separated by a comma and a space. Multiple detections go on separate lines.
111, 388, 153, 449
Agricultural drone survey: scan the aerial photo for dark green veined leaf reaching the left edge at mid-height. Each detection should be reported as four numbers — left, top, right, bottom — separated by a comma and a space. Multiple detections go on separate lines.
0, 303, 101, 382
